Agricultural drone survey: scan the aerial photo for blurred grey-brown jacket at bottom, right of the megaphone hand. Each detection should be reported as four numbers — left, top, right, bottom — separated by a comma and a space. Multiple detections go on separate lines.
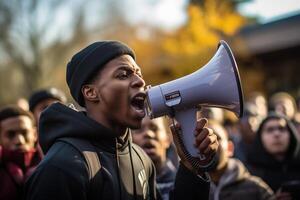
210, 158, 275, 200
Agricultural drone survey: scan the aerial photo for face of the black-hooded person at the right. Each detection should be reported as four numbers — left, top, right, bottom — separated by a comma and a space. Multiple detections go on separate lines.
261, 119, 290, 160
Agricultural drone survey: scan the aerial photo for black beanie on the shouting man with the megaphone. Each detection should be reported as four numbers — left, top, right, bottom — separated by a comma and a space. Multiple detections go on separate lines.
66, 41, 135, 106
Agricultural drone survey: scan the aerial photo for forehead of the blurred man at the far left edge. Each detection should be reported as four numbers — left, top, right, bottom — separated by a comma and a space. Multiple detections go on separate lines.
0, 115, 33, 129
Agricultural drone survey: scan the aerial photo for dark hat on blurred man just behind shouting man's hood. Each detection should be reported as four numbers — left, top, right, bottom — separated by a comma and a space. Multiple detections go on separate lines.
29, 87, 67, 112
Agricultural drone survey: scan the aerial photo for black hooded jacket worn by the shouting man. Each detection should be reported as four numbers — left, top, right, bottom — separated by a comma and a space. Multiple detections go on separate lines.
25, 103, 209, 200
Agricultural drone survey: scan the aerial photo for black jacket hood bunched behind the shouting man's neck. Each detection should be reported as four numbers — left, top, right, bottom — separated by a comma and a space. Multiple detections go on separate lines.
39, 103, 130, 153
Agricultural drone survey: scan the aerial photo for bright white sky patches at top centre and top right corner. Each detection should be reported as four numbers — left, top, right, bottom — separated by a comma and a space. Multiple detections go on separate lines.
126, 0, 300, 30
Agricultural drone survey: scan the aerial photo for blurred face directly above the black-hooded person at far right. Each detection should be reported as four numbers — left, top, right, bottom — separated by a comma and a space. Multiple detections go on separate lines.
275, 98, 295, 119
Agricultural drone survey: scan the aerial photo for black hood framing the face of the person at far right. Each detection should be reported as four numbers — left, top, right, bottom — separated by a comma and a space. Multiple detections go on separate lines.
248, 112, 300, 167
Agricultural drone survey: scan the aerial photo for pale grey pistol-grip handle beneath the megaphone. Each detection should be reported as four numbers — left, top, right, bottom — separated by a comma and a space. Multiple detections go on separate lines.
174, 108, 206, 160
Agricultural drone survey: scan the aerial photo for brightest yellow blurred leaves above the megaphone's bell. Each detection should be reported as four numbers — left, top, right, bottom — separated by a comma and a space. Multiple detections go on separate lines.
163, 0, 245, 56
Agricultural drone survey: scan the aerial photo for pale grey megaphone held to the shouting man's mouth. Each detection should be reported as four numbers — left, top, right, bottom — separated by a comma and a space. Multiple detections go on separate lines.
145, 40, 243, 166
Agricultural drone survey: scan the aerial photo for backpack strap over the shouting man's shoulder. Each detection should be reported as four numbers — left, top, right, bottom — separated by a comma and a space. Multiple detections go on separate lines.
59, 137, 102, 199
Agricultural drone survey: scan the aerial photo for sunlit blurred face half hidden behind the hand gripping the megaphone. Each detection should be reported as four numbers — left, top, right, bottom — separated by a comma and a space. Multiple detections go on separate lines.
208, 123, 234, 171
